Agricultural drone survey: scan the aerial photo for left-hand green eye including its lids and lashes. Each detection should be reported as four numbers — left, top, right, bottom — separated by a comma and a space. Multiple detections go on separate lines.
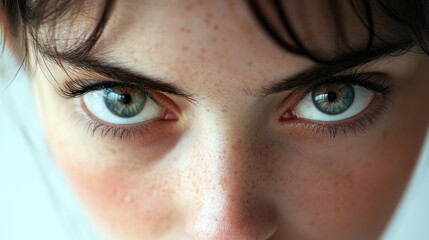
61, 80, 177, 139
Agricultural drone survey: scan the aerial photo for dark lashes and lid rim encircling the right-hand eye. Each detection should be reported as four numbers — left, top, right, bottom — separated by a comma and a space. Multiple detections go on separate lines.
280, 72, 393, 139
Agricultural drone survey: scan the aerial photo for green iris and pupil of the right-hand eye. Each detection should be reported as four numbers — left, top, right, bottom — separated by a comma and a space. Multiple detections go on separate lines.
312, 83, 355, 115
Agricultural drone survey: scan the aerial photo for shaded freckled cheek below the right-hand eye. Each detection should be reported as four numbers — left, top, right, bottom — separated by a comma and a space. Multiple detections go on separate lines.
272, 136, 421, 239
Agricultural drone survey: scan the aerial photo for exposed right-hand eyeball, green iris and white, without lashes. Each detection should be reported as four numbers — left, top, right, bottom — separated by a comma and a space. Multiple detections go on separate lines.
293, 82, 375, 122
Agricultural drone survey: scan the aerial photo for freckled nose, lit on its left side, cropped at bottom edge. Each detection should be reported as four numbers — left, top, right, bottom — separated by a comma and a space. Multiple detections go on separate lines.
182, 110, 276, 240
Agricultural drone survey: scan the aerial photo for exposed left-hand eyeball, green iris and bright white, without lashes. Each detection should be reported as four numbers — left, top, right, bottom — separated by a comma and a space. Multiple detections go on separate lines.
82, 86, 166, 125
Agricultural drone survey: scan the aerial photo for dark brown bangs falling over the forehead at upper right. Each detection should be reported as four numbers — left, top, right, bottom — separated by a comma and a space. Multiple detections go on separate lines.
248, 0, 422, 64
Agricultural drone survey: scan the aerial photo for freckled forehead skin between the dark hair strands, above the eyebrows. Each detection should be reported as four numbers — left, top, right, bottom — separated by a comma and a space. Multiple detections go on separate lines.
99, 1, 308, 88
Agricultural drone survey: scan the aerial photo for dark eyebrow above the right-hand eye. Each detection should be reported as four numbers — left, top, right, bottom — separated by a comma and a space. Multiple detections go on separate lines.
258, 42, 415, 97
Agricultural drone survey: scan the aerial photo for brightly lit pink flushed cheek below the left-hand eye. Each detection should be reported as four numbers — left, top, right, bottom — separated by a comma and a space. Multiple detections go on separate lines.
53, 142, 179, 239
